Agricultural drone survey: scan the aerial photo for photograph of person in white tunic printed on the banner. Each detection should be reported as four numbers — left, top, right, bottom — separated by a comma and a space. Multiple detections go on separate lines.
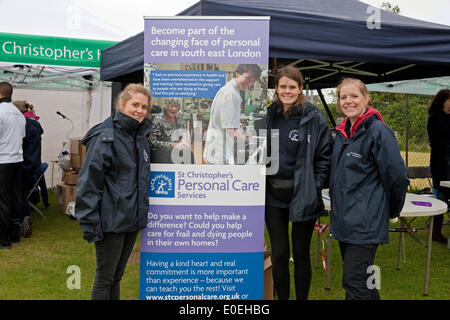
144, 63, 268, 164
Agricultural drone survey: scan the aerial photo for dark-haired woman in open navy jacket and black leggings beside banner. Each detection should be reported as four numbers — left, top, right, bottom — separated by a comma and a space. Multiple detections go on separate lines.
265, 66, 332, 300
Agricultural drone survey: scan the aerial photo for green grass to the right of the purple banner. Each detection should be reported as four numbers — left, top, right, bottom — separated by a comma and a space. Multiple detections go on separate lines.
266, 217, 450, 300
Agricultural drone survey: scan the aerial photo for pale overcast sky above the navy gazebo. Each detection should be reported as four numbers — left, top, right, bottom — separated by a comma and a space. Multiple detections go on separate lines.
72, 0, 450, 39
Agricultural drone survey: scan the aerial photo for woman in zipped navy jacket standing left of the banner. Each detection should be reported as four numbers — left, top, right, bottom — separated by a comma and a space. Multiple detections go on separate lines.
75, 84, 151, 300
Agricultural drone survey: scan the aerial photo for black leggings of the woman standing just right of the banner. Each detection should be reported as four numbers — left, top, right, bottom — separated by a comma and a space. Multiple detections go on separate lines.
265, 206, 316, 300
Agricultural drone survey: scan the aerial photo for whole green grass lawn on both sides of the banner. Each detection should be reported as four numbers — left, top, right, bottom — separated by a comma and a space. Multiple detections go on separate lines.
0, 192, 450, 300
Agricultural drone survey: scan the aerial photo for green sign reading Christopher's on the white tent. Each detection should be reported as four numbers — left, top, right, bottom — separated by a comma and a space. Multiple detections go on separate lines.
0, 32, 117, 68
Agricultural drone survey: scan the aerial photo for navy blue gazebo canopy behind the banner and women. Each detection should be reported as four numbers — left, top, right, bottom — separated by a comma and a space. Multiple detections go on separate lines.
101, 0, 450, 89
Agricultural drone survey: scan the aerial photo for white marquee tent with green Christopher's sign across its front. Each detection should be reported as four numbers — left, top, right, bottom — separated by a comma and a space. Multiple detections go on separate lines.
0, 0, 128, 187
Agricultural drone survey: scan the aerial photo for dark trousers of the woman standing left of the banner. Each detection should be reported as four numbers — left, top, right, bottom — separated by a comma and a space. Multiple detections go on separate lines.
91, 231, 138, 300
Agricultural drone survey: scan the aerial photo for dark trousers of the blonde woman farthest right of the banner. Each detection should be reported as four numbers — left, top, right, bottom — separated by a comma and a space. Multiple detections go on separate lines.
339, 242, 380, 300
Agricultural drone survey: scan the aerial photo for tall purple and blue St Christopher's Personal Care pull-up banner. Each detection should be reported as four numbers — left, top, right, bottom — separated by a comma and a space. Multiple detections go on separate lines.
140, 16, 269, 300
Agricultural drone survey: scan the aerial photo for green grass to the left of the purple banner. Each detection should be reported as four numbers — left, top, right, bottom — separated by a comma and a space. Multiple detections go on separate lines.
0, 191, 139, 300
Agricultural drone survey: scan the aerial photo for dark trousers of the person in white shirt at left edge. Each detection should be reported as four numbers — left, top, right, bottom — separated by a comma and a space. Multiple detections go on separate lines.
0, 162, 22, 245
